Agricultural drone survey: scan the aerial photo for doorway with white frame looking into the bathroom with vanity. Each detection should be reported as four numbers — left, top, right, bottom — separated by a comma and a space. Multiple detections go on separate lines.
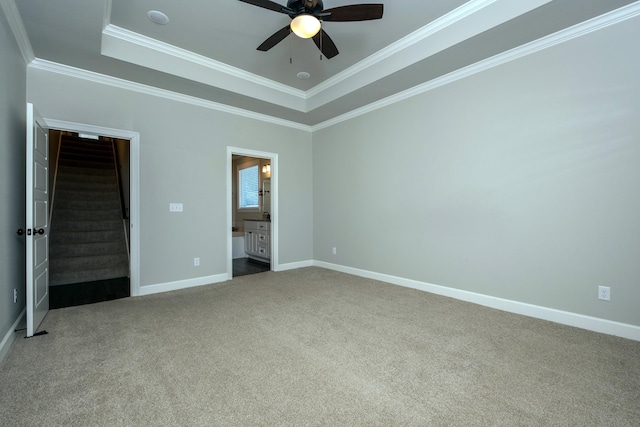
227, 147, 278, 279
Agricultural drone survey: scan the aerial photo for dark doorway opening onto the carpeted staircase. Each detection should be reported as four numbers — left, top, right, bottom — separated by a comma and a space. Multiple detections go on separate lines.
48, 129, 131, 309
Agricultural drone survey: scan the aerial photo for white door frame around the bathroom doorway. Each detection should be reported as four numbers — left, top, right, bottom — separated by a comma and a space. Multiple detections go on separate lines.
226, 146, 280, 280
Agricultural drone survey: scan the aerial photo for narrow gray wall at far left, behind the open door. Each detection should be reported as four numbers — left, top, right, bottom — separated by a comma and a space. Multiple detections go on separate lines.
0, 13, 26, 360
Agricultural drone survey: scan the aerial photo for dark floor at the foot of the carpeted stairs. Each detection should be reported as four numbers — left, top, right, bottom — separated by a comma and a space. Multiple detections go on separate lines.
49, 277, 131, 309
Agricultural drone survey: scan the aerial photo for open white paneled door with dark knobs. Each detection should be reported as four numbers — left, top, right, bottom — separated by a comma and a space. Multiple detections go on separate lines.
26, 104, 49, 337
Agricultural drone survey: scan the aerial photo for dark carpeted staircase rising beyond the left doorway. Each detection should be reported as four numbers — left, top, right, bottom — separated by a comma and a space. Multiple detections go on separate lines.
49, 135, 129, 286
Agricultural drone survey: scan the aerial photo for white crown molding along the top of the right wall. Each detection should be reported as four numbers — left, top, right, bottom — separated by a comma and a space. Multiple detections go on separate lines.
311, 2, 640, 132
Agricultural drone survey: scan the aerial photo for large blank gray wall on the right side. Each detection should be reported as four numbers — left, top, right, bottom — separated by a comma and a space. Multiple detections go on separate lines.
313, 18, 640, 325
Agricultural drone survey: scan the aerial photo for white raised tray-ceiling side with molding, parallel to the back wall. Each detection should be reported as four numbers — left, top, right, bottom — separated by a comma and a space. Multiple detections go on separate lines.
102, 24, 306, 111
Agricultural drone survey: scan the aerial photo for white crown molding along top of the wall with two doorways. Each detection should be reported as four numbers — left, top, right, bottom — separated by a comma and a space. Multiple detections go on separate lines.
29, 59, 311, 132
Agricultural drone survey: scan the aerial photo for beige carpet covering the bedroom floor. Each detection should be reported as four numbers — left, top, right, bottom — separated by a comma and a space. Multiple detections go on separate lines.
0, 268, 640, 426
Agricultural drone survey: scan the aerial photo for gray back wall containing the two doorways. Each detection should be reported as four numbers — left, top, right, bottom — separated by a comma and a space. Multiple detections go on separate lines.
27, 69, 313, 286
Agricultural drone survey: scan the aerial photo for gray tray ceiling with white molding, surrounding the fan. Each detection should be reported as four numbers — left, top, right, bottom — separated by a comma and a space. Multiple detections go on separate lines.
10, 0, 638, 127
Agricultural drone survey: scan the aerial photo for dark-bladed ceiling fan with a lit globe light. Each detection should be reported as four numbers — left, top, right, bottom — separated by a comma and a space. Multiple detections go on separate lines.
240, 0, 383, 59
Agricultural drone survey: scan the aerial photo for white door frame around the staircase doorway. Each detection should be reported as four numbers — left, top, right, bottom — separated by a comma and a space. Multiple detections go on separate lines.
44, 117, 140, 296
